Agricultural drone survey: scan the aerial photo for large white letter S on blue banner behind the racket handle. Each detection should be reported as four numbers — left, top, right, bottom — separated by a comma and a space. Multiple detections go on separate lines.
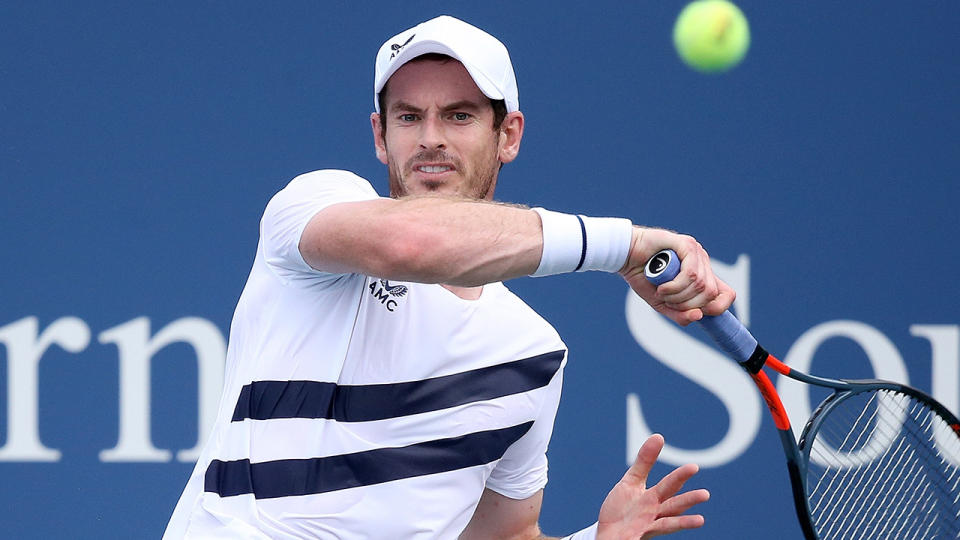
626, 255, 761, 467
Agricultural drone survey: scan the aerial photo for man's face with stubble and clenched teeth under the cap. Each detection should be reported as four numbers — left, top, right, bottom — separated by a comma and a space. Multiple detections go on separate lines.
371, 59, 512, 199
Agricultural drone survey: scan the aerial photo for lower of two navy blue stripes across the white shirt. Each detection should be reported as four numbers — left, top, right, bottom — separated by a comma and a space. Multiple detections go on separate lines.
203, 422, 533, 499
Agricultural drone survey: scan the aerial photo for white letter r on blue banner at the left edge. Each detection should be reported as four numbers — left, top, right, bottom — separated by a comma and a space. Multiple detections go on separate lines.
0, 317, 90, 461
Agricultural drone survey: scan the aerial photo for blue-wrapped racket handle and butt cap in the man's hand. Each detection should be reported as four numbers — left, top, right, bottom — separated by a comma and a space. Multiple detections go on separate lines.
644, 249, 757, 362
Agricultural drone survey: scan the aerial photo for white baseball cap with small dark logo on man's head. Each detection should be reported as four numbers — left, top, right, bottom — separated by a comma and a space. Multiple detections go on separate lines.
373, 15, 520, 112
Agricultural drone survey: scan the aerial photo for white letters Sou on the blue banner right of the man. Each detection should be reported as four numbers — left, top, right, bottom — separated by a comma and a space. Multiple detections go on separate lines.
626, 255, 960, 467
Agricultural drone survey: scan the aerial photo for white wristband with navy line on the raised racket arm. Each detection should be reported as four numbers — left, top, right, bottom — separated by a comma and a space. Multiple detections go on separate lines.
531, 208, 633, 277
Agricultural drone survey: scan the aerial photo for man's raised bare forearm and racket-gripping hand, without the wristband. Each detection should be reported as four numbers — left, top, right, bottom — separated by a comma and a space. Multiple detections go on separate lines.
299, 197, 734, 325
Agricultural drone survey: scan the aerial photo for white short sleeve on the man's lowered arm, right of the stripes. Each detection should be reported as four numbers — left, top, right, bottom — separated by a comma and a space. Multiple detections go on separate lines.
486, 362, 566, 500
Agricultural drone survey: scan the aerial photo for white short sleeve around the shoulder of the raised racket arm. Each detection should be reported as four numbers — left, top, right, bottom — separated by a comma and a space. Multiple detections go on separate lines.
260, 169, 378, 281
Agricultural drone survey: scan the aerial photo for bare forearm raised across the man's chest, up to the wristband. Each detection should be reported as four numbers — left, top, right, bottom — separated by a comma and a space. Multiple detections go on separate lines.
300, 197, 543, 286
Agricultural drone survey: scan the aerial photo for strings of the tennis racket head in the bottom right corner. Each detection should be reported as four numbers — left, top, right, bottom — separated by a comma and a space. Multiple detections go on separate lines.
806, 390, 960, 540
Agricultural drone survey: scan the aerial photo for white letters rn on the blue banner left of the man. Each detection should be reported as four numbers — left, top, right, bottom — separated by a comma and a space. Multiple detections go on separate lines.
0, 317, 226, 462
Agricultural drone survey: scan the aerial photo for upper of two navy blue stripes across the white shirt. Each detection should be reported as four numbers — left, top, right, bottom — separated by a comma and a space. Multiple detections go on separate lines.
233, 350, 564, 422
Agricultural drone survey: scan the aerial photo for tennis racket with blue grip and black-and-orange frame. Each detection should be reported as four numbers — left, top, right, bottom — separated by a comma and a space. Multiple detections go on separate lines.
645, 250, 960, 540
